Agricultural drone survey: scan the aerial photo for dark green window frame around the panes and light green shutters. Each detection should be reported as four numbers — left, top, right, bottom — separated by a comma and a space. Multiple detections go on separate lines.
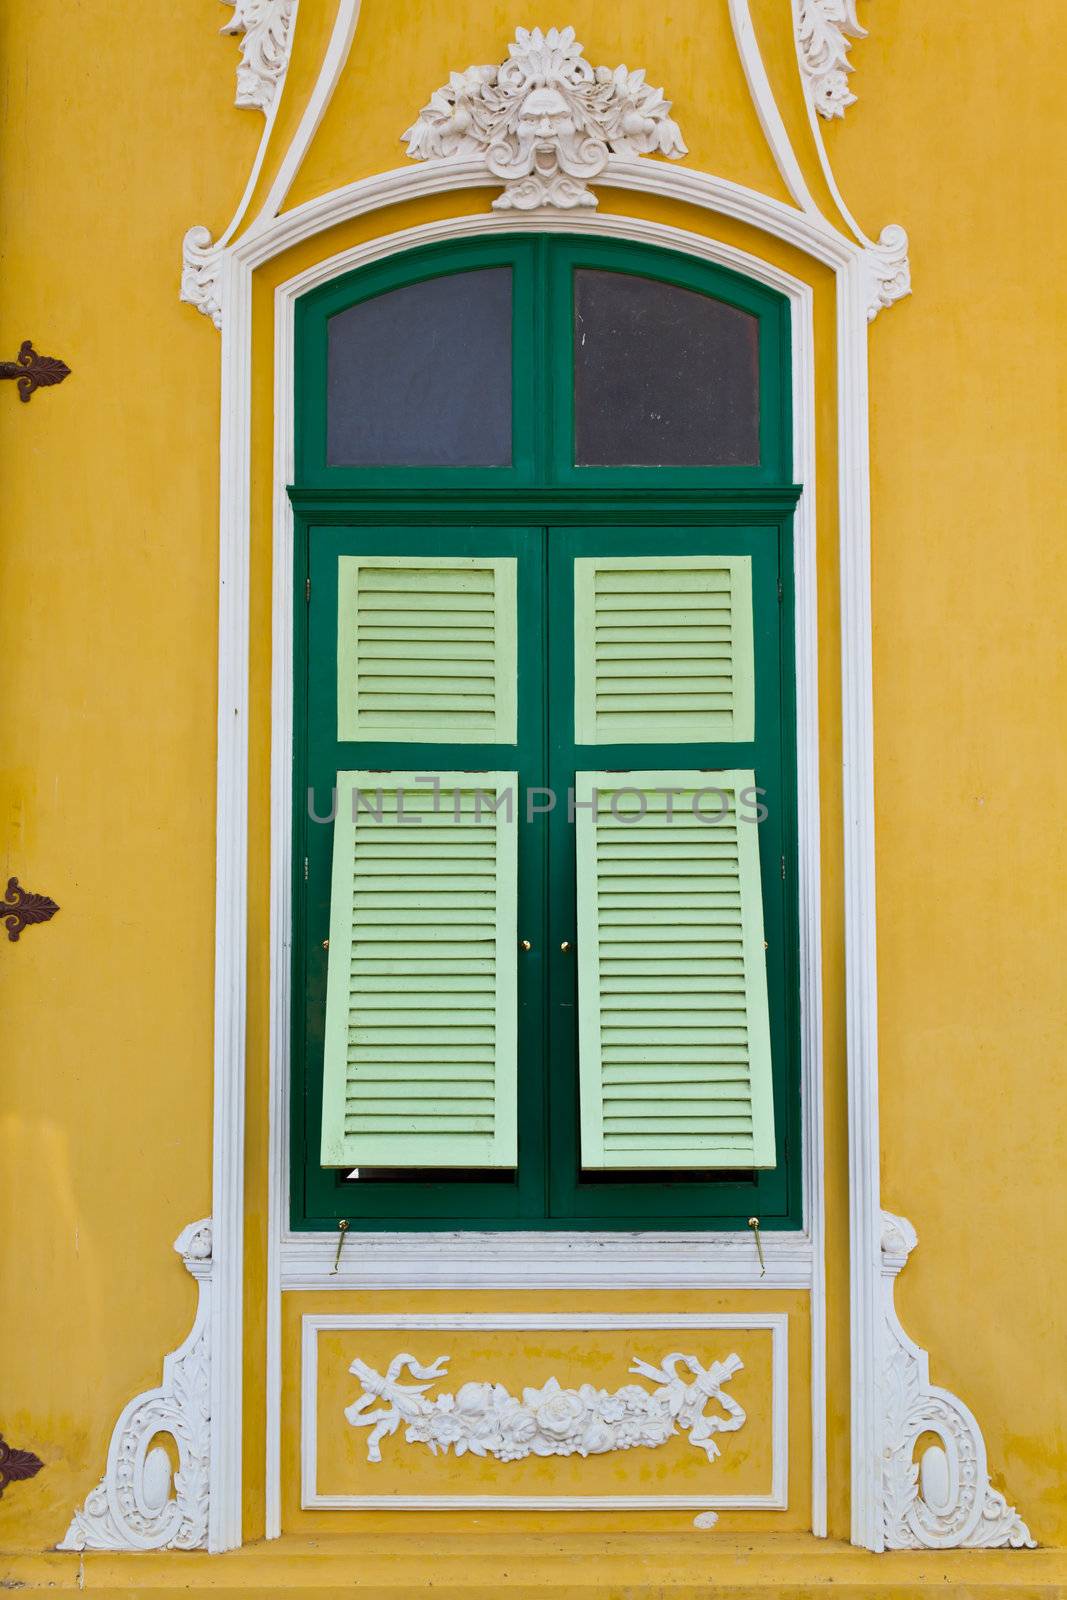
290, 235, 801, 1230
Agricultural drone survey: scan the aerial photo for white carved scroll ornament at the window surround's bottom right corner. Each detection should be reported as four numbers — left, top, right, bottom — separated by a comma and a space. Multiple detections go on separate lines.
880, 1211, 1033, 1550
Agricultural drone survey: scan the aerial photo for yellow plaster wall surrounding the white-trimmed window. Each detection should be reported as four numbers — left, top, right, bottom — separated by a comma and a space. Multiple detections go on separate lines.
0, 0, 1067, 1574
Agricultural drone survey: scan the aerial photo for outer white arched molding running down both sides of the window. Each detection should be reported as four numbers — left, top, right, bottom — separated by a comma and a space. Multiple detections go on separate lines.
211, 158, 881, 1549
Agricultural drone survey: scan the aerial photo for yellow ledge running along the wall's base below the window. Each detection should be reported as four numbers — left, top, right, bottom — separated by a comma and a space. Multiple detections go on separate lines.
0, 1531, 1067, 1600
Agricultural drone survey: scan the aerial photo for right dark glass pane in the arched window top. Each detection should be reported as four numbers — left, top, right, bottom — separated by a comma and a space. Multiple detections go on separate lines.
574, 267, 760, 467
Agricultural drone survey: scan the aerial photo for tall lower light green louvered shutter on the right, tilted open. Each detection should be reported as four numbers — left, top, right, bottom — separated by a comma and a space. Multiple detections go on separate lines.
576, 771, 774, 1168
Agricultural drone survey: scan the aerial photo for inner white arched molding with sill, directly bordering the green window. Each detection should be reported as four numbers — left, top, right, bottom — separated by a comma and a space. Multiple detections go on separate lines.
266, 203, 840, 1538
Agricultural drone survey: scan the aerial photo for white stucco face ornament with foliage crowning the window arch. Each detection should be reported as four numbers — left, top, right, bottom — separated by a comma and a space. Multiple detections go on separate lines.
402, 27, 688, 211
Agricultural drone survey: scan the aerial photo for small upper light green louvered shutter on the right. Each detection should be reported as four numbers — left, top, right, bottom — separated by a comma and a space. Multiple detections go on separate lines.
574, 555, 753, 744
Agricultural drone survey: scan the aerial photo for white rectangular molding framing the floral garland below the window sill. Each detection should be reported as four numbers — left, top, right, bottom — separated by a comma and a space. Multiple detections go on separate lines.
301, 1312, 789, 1510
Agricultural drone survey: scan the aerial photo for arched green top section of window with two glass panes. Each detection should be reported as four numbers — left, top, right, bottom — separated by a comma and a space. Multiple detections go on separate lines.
298, 235, 792, 488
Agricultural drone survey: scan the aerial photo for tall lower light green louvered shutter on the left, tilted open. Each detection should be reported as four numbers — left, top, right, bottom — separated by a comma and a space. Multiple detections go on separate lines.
322, 773, 517, 1166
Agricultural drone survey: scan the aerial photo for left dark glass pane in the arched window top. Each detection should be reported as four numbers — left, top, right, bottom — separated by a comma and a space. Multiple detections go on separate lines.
326, 267, 512, 467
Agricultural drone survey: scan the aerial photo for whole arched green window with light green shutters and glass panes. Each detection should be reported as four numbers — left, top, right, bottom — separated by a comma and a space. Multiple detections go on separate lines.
291, 235, 800, 1229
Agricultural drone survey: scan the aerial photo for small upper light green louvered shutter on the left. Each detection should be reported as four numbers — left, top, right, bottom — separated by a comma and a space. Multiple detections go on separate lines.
338, 555, 515, 744
